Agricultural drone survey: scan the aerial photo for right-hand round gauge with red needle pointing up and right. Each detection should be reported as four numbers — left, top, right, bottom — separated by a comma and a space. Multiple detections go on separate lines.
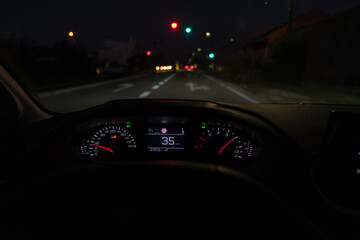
194, 125, 253, 161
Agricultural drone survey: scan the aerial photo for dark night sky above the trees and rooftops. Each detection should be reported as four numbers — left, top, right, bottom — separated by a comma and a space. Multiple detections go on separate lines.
0, 0, 360, 59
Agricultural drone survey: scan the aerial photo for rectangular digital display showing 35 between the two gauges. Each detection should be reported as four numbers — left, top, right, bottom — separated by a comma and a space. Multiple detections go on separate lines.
147, 126, 184, 152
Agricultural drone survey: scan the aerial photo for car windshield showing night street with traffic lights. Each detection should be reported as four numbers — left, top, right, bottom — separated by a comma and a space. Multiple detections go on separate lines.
0, 0, 360, 113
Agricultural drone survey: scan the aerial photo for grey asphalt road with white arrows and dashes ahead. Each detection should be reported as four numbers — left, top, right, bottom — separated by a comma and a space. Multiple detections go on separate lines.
34, 72, 262, 113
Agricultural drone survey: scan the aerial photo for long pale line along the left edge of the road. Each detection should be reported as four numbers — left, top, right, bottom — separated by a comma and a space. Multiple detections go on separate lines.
37, 74, 149, 98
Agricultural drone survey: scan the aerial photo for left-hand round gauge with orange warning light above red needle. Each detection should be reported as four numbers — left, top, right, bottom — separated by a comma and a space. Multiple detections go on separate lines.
81, 125, 136, 161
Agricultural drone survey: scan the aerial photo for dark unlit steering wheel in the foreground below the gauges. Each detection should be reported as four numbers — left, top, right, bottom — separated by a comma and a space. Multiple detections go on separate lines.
0, 161, 324, 239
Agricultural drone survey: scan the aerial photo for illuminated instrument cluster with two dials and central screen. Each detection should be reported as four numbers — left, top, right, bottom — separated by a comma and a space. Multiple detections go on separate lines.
75, 116, 265, 165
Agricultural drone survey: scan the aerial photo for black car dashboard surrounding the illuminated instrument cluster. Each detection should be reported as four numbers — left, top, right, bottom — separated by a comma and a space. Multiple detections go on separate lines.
1, 100, 360, 239
